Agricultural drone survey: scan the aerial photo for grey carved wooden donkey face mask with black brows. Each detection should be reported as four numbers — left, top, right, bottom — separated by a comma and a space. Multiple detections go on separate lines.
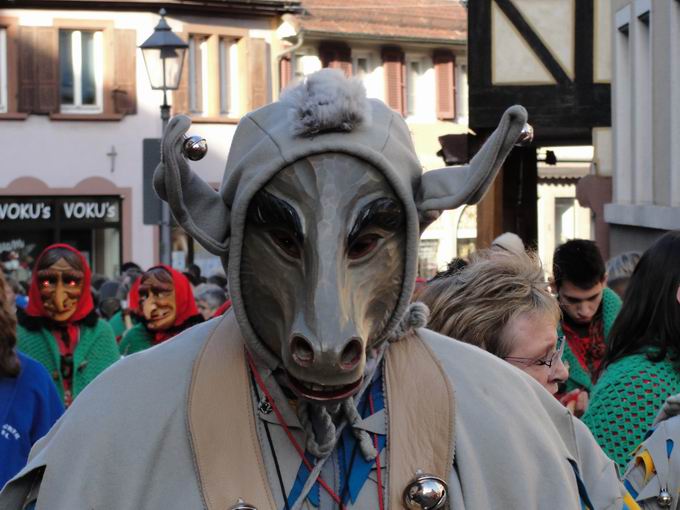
241, 154, 406, 401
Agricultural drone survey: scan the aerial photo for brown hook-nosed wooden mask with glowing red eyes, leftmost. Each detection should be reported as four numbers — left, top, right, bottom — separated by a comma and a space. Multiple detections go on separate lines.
38, 258, 85, 322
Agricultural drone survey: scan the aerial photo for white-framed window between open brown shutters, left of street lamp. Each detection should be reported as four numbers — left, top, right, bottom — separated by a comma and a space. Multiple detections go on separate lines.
59, 30, 104, 113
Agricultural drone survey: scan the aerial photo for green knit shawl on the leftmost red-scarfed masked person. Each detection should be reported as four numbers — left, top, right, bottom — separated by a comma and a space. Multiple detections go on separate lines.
17, 319, 120, 401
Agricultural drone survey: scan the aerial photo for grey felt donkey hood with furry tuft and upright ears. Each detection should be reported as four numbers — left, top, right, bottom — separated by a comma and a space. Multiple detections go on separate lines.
154, 69, 527, 368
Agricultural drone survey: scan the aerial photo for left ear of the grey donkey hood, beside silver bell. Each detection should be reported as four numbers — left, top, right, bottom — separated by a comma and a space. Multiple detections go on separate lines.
153, 115, 230, 256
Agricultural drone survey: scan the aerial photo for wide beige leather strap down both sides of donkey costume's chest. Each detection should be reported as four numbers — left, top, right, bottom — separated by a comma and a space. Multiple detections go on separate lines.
188, 313, 454, 510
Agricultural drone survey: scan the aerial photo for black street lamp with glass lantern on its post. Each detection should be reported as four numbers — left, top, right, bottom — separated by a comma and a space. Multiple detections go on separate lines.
139, 9, 189, 265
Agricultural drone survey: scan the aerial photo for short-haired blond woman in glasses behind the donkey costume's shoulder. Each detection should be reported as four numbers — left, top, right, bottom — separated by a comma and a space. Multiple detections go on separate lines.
419, 250, 634, 508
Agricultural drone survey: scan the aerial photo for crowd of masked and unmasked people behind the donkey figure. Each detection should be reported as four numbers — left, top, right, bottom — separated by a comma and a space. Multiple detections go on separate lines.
0, 232, 680, 497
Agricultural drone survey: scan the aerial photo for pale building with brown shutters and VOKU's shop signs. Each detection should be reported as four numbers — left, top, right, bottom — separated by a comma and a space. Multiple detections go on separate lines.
0, 0, 297, 276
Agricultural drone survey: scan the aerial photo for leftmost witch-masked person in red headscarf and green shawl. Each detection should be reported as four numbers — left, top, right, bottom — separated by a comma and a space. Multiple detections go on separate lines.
17, 244, 120, 407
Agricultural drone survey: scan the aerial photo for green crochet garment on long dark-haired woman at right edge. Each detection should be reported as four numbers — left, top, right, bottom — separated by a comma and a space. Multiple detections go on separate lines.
583, 354, 680, 473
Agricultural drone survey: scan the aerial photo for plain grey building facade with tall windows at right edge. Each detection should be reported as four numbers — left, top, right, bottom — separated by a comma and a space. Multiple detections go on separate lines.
604, 0, 680, 254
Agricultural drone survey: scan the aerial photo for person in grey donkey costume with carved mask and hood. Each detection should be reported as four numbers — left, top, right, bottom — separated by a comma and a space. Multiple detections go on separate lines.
0, 70, 636, 510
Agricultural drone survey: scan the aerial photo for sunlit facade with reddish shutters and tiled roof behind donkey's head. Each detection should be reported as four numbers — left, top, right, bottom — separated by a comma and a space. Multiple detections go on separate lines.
278, 0, 468, 277
